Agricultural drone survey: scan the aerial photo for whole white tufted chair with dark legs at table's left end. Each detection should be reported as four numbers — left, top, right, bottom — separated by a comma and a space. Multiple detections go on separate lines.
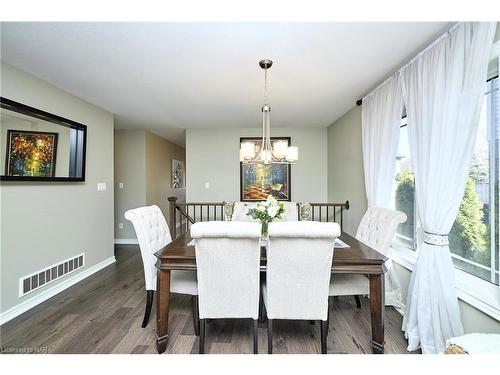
125, 206, 199, 335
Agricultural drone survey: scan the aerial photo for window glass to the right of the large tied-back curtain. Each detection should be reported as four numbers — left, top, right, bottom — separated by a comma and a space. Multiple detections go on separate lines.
449, 78, 500, 284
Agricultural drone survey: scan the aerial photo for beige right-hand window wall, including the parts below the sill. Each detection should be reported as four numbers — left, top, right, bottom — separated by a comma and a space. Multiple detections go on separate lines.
328, 106, 500, 333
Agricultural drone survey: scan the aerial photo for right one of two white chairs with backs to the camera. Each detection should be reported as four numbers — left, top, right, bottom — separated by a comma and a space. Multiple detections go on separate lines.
262, 221, 340, 353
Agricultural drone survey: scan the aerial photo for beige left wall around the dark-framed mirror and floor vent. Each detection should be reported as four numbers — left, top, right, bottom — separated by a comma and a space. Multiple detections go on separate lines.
0, 63, 114, 312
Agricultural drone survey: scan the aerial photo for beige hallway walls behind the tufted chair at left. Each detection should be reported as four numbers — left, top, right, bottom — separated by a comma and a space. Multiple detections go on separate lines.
115, 129, 186, 239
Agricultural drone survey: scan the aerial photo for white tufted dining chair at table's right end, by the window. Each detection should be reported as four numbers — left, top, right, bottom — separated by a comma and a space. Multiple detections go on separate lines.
330, 207, 406, 308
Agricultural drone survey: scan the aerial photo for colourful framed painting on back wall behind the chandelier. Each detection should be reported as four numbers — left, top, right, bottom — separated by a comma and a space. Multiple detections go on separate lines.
240, 137, 291, 202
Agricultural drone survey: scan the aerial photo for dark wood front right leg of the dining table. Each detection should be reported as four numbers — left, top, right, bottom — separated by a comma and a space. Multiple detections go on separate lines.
370, 274, 385, 354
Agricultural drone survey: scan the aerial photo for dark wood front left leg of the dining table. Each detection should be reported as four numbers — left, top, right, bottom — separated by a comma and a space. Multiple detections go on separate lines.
156, 270, 170, 353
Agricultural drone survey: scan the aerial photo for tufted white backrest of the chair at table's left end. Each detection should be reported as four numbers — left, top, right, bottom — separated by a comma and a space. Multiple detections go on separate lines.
125, 206, 172, 290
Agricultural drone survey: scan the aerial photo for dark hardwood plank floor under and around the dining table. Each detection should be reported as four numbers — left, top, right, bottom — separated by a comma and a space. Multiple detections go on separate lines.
0, 245, 418, 353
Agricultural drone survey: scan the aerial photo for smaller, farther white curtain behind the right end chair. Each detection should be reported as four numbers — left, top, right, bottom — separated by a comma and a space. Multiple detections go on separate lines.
361, 75, 403, 308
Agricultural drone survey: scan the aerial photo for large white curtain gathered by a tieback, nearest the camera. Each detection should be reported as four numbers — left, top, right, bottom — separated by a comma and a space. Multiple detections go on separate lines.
401, 23, 496, 353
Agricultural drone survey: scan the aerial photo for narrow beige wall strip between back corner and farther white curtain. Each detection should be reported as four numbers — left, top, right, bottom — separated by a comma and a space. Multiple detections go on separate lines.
328, 106, 367, 235
